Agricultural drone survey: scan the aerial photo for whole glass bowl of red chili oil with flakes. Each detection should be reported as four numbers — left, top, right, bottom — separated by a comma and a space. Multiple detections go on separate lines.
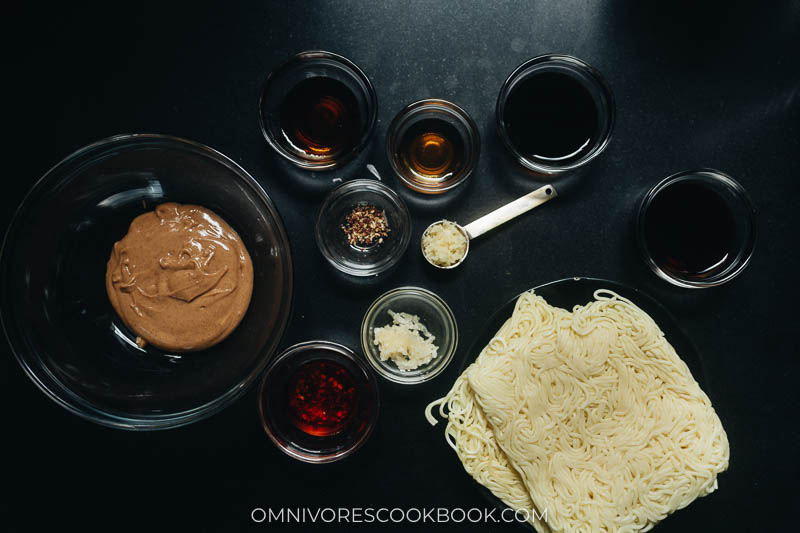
258, 341, 380, 463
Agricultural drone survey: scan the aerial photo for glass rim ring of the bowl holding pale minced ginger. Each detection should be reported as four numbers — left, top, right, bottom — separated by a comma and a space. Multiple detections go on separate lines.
361, 285, 458, 385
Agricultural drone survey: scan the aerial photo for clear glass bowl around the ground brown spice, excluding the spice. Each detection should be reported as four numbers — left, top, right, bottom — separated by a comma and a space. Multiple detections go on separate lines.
316, 179, 411, 276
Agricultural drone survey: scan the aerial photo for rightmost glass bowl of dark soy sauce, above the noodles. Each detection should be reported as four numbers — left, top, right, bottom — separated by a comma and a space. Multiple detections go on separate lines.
636, 169, 758, 289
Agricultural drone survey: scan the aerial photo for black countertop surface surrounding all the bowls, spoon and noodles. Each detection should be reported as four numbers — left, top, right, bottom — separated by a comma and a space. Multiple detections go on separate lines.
0, 0, 800, 533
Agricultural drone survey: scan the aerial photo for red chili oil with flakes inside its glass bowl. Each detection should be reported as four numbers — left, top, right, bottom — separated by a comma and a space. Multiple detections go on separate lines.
288, 360, 358, 437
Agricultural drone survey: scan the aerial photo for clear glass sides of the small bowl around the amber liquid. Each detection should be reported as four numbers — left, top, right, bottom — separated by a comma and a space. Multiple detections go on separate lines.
386, 99, 481, 194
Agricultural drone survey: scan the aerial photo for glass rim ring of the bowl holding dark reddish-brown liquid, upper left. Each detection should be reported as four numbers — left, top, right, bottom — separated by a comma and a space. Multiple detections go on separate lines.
258, 50, 378, 171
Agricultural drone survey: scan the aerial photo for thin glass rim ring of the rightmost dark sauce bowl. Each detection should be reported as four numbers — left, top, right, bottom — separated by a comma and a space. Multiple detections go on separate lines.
636, 167, 758, 289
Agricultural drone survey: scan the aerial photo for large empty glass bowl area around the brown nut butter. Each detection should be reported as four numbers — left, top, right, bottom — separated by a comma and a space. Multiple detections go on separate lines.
0, 135, 292, 429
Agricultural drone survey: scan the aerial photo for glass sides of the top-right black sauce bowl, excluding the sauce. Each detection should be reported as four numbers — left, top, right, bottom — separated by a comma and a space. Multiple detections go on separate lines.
495, 54, 616, 176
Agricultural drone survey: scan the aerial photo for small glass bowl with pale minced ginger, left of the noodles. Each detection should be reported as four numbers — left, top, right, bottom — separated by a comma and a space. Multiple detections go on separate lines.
361, 287, 458, 385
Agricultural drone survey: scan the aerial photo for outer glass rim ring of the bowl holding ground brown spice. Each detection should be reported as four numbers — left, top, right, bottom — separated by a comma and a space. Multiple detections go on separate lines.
314, 178, 411, 276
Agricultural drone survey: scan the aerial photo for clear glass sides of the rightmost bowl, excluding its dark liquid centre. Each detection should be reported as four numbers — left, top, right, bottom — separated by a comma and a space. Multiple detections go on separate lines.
636, 169, 758, 289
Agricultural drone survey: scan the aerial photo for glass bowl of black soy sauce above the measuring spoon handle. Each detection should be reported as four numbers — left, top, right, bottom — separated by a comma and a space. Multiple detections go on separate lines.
495, 54, 616, 176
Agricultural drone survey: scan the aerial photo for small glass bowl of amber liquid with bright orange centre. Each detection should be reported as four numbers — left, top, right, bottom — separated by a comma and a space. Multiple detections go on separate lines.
386, 99, 481, 194
